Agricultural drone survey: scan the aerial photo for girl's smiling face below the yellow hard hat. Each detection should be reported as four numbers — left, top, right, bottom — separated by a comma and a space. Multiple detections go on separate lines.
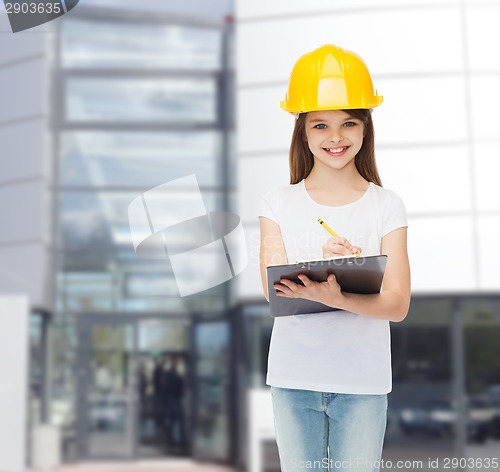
305, 110, 364, 170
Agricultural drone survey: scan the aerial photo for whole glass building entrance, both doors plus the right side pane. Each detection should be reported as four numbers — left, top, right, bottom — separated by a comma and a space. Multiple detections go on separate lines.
75, 314, 232, 462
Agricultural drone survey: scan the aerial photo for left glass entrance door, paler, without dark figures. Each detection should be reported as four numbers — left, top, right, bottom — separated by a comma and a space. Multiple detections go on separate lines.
78, 319, 138, 459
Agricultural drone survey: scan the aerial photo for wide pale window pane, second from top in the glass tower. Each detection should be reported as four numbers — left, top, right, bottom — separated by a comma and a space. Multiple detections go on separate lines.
65, 78, 217, 124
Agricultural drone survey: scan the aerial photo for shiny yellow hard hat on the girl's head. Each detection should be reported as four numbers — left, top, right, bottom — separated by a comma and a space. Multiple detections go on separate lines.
281, 44, 384, 113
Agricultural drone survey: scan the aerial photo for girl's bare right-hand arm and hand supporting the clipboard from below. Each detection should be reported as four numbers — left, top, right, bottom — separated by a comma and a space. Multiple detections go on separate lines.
276, 228, 410, 321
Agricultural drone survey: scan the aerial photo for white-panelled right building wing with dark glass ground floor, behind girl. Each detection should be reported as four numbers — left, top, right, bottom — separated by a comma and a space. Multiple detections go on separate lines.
235, 0, 500, 470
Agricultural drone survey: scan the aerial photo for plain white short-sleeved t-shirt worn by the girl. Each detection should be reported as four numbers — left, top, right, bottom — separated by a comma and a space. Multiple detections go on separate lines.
260, 181, 407, 394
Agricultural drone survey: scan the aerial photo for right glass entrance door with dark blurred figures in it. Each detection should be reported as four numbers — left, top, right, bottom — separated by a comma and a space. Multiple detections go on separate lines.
137, 318, 192, 457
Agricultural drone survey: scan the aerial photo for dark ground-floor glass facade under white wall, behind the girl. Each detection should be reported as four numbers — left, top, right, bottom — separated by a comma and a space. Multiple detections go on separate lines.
237, 295, 500, 472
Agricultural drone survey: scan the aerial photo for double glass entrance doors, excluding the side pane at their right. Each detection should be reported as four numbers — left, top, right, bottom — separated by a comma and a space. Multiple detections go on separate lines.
77, 316, 193, 459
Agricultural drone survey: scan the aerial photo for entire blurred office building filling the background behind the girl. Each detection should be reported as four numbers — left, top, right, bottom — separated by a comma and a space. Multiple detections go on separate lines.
0, 0, 500, 472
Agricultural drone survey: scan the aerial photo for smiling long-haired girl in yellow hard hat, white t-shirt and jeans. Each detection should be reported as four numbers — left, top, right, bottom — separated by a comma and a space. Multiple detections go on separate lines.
260, 45, 410, 472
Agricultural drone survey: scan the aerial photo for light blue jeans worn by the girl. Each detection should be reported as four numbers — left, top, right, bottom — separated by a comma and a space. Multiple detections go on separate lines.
271, 387, 387, 472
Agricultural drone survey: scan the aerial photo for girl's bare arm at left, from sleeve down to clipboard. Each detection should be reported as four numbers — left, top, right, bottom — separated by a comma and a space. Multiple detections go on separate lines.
259, 216, 288, 301
